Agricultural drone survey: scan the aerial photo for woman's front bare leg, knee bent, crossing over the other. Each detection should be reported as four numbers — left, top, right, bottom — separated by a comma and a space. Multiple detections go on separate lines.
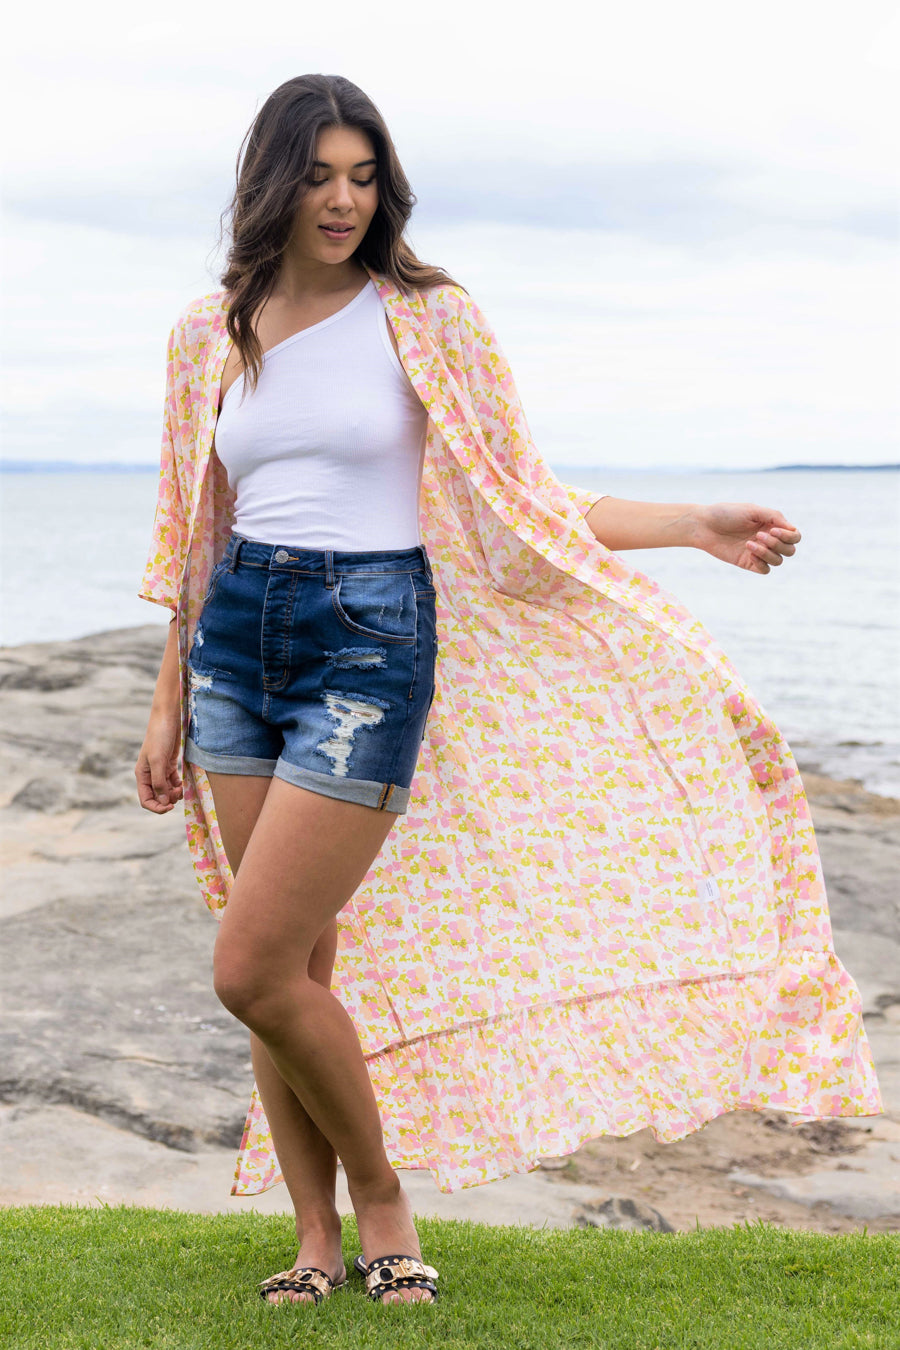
215, 779, 430, 1301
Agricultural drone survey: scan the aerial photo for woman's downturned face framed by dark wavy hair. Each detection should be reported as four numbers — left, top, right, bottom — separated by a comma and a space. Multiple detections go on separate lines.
291, 127, 378, 262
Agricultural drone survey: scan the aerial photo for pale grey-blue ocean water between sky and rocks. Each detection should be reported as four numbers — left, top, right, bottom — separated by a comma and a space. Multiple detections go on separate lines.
0, 464, 900, 797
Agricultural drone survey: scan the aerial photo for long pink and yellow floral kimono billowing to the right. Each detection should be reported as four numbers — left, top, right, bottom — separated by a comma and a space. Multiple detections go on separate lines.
139, 260, 882, 1195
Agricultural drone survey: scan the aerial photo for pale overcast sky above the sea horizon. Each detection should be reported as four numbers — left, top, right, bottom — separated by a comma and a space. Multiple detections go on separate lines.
3, 0, 900, 468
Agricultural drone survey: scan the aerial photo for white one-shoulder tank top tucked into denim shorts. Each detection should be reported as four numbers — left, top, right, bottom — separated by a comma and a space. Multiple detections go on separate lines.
215, 277, 428, 551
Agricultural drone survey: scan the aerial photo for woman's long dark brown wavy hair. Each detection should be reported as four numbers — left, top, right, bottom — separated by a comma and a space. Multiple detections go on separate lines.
220, 74, 466, 389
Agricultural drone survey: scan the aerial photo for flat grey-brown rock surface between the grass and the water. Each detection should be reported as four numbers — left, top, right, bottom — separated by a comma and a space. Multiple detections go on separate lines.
0, 625, 900, 1231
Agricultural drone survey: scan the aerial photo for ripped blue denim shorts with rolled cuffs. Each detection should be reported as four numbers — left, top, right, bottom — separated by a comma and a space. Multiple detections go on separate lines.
185, 531, 437, 814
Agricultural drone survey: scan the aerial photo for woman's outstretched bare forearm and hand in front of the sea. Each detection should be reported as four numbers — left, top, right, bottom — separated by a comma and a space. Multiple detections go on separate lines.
584, 497, 800, 574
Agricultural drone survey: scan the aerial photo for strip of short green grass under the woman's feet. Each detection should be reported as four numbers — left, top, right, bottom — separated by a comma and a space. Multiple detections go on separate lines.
0, 1206, 900, 1350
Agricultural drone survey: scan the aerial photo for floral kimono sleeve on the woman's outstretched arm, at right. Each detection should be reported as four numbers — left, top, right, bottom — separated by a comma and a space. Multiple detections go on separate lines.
447, 293, 609, 516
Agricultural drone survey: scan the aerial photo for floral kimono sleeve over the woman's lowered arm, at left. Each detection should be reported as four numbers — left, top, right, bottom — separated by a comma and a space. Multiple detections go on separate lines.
138, 315, 188, 610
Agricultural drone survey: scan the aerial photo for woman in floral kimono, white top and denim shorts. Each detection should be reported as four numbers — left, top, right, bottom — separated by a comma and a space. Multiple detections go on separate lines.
135, 76, 881, 1303
